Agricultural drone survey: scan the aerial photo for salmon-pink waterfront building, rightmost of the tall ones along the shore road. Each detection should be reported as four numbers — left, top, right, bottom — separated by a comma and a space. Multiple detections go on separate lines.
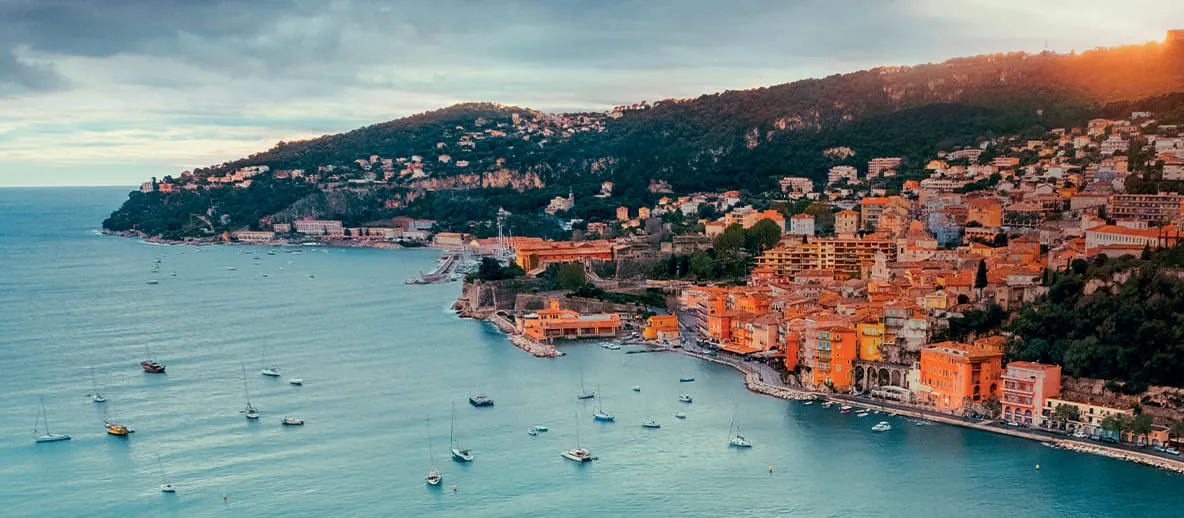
1000, 362, 1061, 426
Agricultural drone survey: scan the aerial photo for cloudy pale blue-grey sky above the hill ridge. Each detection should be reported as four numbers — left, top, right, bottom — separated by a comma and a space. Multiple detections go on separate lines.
0, 0, 1184, 187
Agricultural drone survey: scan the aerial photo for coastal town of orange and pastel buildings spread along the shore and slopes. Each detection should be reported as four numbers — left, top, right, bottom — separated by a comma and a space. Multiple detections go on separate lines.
106, 35, 1184, 470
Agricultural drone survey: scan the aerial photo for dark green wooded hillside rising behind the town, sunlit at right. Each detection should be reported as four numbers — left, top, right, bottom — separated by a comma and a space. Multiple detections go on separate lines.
104, 37, 1184, 233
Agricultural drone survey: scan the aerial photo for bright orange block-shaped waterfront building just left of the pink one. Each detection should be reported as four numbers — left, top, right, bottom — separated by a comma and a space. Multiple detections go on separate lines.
921, 342, 1003, 412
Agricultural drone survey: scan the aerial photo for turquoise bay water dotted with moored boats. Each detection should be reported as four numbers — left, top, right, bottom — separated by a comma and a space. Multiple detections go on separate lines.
0, 188, 1184, 517
